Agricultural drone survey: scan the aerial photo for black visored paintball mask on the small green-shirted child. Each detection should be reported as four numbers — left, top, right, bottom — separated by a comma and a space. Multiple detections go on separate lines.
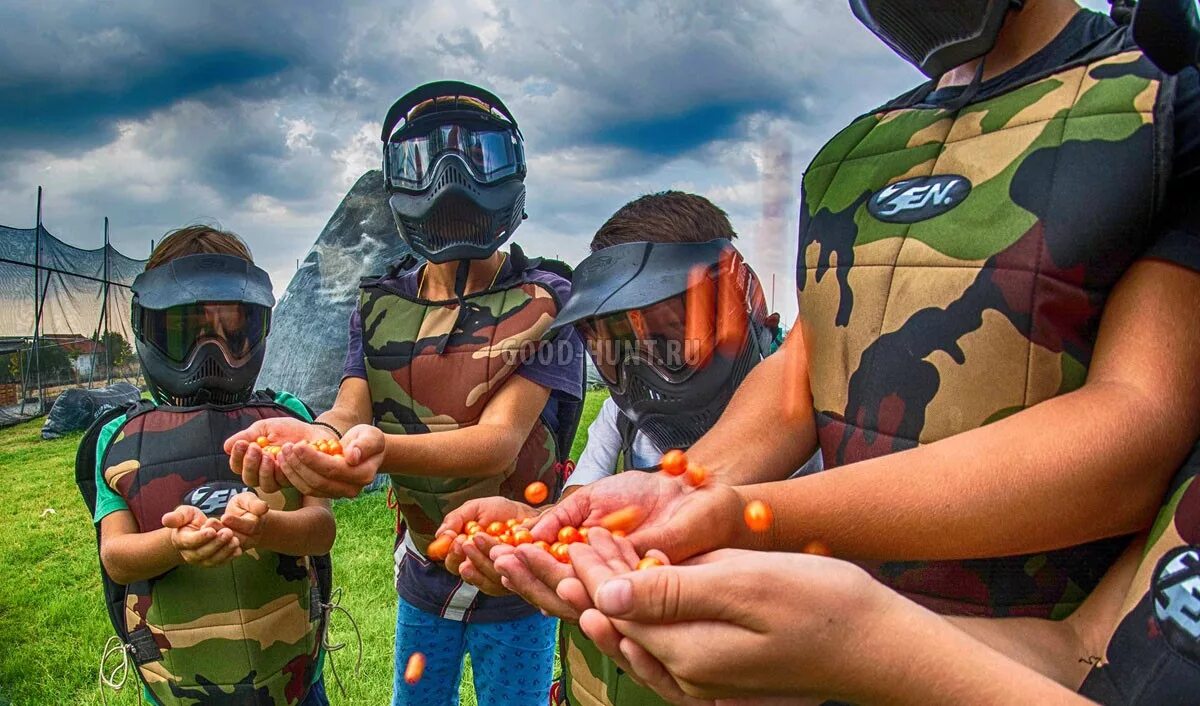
132, 255, 275, 406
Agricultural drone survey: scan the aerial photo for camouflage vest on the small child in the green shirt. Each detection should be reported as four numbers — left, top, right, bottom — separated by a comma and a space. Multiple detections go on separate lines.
102, 402, 324, 706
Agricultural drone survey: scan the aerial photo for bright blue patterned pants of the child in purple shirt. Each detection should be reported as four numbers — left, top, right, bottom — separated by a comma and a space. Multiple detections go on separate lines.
391, 598, 557, 706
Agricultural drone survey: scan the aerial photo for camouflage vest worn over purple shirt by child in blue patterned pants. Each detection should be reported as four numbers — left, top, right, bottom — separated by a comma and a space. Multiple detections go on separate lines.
359, 258, 560, 554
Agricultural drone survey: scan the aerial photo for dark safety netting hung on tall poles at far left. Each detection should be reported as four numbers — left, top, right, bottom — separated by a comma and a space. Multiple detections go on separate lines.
0, 225, 145, 426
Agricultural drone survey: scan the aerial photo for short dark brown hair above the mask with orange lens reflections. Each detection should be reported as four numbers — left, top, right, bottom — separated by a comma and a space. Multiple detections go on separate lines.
592, 191, 738, 252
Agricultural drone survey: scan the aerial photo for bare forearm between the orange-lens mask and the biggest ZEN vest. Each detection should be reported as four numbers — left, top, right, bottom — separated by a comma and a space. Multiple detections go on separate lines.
688, 336, 817, 485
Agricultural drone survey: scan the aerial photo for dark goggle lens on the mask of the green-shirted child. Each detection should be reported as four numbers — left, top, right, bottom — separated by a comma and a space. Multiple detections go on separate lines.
140, 301, 271, 363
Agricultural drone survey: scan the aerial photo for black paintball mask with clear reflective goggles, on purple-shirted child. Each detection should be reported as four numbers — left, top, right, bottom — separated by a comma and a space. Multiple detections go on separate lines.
382, 80, 526, 263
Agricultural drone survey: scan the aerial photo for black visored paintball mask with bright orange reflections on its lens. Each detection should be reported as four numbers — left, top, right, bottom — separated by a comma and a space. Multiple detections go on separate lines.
554, 239, 768, 449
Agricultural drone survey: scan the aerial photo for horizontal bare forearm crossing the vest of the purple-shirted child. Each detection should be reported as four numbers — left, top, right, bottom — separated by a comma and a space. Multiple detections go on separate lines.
379, 424, 521, 478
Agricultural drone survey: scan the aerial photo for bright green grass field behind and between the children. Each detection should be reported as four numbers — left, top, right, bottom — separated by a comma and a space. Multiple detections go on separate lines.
0, 393, 605, 706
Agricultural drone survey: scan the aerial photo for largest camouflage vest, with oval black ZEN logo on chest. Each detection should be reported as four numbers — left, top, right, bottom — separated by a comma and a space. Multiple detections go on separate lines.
797, 30, 1174, 616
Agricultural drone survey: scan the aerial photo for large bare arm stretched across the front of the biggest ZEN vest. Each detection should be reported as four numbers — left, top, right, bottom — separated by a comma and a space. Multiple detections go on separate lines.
745, 384, 1188, 560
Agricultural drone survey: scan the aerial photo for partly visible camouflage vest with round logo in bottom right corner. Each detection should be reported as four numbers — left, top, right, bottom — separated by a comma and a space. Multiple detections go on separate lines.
1080, 453, 1200, 706
